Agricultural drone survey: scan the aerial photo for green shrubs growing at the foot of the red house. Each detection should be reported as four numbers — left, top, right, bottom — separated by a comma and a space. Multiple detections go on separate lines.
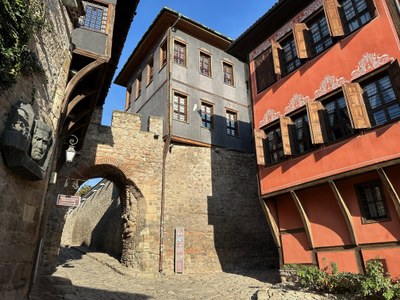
290, 260, 400, 300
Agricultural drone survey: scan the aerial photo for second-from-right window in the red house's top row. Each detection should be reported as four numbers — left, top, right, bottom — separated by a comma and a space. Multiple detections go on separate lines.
308, 13, 333, 55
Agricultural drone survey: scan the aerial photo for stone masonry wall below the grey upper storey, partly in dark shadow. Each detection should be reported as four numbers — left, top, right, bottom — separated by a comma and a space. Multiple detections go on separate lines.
163, 145, 277, 273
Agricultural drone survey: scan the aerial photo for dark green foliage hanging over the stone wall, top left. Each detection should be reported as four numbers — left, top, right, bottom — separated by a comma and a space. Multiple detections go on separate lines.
0, 0, 45, 88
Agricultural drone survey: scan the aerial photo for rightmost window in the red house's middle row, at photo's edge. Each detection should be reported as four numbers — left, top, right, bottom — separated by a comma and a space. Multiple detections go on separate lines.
362, 73, 400, 126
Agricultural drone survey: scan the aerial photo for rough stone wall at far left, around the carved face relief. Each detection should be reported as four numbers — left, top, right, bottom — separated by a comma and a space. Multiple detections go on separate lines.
0, 0, 71, 300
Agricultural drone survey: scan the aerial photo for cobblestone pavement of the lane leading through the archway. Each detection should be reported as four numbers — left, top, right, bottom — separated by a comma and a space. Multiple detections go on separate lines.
30, 248, 343, 300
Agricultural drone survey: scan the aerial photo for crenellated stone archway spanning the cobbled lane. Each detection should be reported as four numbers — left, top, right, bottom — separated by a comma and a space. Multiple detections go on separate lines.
41, 111, 163, 272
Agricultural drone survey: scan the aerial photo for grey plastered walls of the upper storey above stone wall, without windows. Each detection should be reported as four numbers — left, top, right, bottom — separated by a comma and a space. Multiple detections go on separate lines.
128, 30, 253, 152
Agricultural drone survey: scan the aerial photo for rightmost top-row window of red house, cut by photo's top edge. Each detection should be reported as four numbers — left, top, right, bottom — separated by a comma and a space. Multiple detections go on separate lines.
339, 0, 374, 33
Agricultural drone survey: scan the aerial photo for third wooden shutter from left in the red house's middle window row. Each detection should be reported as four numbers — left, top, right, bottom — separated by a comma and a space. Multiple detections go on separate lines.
306, 101, 327, 144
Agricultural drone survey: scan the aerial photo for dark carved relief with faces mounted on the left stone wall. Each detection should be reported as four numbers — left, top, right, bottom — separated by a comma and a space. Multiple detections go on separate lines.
2, 102, 53, 180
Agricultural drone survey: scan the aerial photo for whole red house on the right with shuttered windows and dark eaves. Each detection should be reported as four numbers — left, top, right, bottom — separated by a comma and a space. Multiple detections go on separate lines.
229, 0, 400, 278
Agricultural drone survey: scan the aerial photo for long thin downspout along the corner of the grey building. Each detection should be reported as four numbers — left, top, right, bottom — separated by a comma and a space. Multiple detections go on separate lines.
158, 14, 181, 273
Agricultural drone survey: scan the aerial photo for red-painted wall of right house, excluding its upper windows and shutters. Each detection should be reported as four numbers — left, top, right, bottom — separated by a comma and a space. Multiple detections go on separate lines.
233, 0, 400, 278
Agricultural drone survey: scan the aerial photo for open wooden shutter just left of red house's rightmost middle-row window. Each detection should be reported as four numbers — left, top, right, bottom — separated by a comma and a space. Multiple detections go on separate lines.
342, 83, 371, 129
